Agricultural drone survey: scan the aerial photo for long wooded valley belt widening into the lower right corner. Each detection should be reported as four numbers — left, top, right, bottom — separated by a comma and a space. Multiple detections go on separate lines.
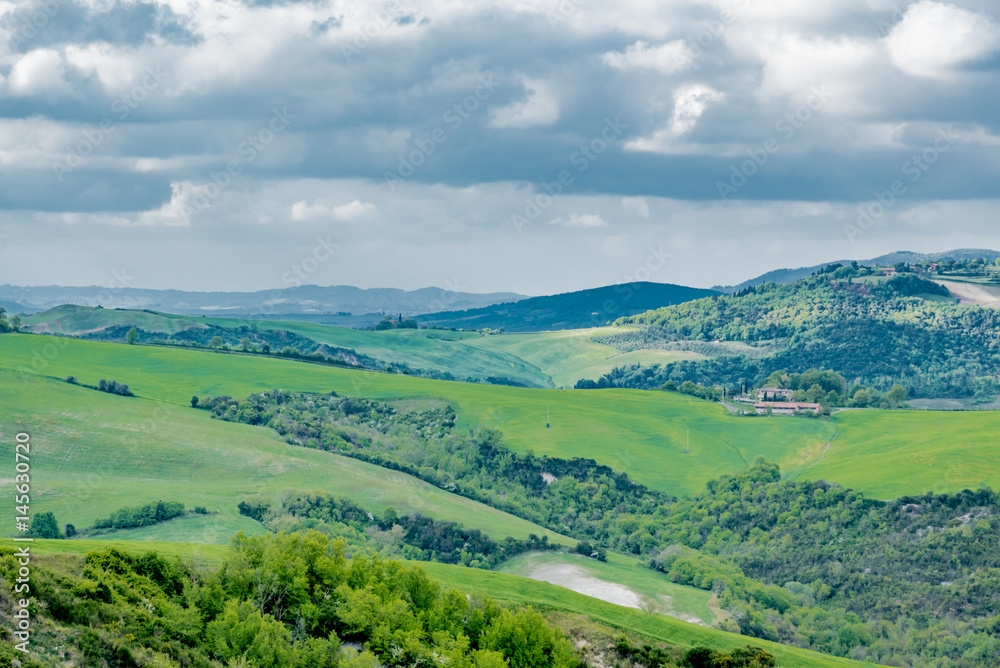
203, 388, 1000, 668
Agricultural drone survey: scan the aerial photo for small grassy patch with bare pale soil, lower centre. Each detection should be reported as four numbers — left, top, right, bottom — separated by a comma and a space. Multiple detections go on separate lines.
497, 552, 715, 626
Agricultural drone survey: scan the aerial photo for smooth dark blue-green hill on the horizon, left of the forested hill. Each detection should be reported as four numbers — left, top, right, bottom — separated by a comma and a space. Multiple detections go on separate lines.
416, 282, 719, 332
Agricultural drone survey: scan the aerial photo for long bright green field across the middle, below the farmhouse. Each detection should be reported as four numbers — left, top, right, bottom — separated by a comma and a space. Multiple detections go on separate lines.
0, 335, 1000, 500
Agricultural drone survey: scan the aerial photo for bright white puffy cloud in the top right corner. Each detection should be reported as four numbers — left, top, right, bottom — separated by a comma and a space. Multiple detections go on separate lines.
885, 0, 1000, 78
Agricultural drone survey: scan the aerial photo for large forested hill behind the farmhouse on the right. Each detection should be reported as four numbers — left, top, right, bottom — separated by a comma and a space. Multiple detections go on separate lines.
600, 266, 1000, 407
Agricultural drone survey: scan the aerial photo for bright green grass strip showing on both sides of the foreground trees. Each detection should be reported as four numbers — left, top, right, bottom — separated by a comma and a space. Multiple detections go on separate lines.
32, 540, 873, 668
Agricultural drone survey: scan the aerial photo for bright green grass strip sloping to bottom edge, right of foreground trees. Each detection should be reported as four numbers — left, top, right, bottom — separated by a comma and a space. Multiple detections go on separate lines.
421, 563, 873, 668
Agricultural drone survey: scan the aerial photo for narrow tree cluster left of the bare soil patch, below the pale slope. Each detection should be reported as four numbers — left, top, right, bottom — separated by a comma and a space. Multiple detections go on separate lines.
239, 492, 559, 569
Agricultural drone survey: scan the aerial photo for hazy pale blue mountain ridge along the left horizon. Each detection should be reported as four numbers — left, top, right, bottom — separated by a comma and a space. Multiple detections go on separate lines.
0, 285, 525, 317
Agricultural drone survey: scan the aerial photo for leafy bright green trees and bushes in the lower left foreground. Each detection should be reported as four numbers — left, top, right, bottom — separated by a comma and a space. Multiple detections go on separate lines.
0, 532, 580, 668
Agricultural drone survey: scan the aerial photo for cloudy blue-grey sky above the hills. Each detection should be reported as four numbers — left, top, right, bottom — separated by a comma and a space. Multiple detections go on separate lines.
0, 0, 1000, 295
